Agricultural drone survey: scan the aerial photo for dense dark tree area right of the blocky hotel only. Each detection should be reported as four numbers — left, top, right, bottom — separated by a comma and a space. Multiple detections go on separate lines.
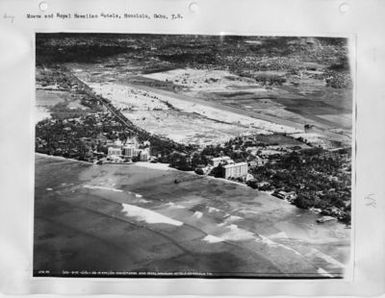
248, 148, 351, 223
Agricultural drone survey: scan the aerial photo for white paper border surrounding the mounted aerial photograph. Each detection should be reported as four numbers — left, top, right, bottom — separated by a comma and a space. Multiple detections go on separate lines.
0, 0, 385, 295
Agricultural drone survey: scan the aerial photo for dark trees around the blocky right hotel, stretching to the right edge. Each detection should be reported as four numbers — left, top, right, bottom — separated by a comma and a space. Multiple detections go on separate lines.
164, 135, 351, 224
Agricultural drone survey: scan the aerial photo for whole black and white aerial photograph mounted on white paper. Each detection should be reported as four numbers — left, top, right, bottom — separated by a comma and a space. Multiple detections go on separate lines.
33, 33, 354, 279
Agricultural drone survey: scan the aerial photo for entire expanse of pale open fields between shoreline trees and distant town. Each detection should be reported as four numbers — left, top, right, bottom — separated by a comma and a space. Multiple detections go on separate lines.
67, 55, 352, 148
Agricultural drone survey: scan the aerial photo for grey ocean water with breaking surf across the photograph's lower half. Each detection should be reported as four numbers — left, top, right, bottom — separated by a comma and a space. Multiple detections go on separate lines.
34, 155, 350, 277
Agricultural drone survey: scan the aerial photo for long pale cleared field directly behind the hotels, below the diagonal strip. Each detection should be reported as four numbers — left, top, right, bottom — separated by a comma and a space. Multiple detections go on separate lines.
75, 65, 298, 145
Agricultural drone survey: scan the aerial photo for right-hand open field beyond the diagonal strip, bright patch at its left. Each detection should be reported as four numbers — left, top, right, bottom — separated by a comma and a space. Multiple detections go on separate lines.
140, 69, 352, 143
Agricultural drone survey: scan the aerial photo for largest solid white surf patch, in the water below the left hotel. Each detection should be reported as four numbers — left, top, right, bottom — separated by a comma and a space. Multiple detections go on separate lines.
122, 203, 183, 226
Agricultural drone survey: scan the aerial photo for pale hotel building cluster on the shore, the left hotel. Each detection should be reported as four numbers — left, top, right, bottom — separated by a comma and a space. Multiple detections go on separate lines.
107, 138, 151, 162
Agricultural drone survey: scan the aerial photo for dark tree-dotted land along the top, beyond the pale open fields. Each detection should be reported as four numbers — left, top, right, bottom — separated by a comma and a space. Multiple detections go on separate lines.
36, 33, 351, 88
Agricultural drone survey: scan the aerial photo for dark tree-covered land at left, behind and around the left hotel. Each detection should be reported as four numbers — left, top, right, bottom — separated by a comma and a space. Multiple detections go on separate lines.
35, 68, 195, 162
